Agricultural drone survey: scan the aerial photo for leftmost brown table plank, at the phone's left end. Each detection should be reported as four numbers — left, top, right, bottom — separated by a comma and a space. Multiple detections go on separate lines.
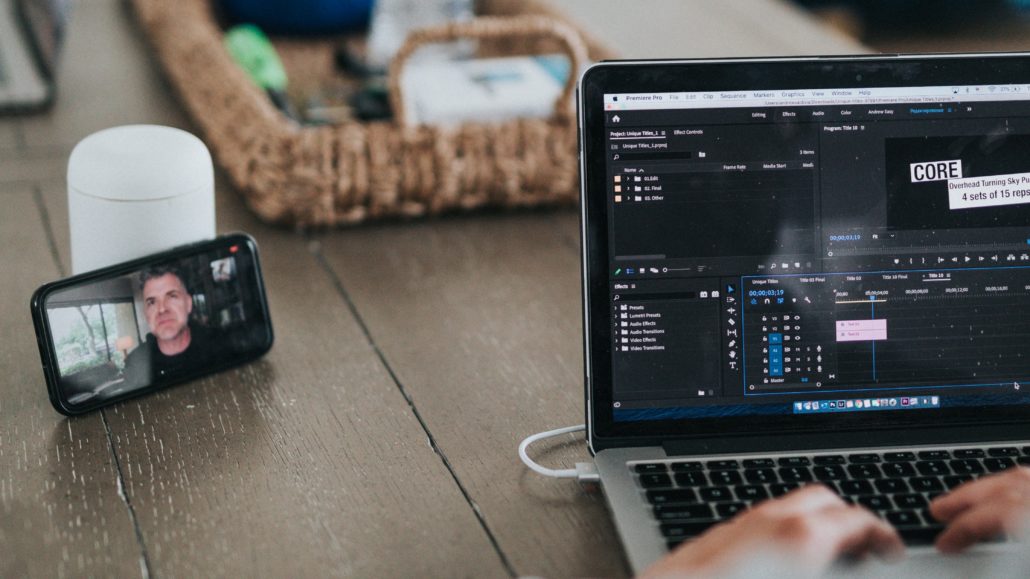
0, 188, 141, 577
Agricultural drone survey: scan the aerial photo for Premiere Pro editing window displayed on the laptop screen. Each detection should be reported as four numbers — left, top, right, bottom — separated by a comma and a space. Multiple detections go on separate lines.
605, 84, 1030, 420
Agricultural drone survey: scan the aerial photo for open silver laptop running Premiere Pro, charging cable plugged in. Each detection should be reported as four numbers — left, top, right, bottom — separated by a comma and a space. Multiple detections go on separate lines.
577, 54, 1030, 572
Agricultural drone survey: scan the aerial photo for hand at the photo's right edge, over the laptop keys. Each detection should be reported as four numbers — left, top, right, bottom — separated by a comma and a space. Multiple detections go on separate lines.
930, 461, 1030, 553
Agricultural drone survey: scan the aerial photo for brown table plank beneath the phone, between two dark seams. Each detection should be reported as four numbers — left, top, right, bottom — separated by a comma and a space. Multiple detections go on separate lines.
36, 178, 507, 577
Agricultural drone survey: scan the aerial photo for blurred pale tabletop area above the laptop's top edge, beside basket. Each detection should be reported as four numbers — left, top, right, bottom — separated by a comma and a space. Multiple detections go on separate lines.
548, 0, 867, 59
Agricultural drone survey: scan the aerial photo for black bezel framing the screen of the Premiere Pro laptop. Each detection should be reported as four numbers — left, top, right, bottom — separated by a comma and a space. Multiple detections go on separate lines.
577, 54, 1030, 450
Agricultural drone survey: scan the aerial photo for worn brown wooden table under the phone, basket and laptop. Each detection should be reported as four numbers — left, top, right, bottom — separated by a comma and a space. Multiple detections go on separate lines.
0, 0, 851, 577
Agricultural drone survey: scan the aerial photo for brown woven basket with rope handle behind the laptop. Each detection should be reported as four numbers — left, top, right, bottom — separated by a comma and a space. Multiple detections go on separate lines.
127, 0, 608, 228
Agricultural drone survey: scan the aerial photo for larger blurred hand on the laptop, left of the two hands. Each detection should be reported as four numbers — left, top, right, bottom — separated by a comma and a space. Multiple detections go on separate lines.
643, 485, 904, 578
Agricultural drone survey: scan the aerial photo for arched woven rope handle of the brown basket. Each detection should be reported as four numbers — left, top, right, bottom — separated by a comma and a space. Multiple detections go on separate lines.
388, 15, 587, 126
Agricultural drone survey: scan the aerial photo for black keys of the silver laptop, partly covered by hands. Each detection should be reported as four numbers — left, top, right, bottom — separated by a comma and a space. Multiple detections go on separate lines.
629, 446, 1030, 549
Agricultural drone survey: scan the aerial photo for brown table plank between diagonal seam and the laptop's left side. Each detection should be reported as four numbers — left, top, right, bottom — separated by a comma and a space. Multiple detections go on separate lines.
320, 212, 626, 577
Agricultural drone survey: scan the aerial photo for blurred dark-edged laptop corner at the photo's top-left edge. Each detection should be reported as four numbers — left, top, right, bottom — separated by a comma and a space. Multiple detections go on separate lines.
0, 0, 68, 113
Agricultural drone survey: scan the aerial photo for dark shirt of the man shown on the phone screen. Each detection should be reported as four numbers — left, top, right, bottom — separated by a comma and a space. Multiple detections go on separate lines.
125, 323, 216, 388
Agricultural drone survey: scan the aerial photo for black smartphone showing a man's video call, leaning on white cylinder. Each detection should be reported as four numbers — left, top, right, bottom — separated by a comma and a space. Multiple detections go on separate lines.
32, 234, 274, 415
